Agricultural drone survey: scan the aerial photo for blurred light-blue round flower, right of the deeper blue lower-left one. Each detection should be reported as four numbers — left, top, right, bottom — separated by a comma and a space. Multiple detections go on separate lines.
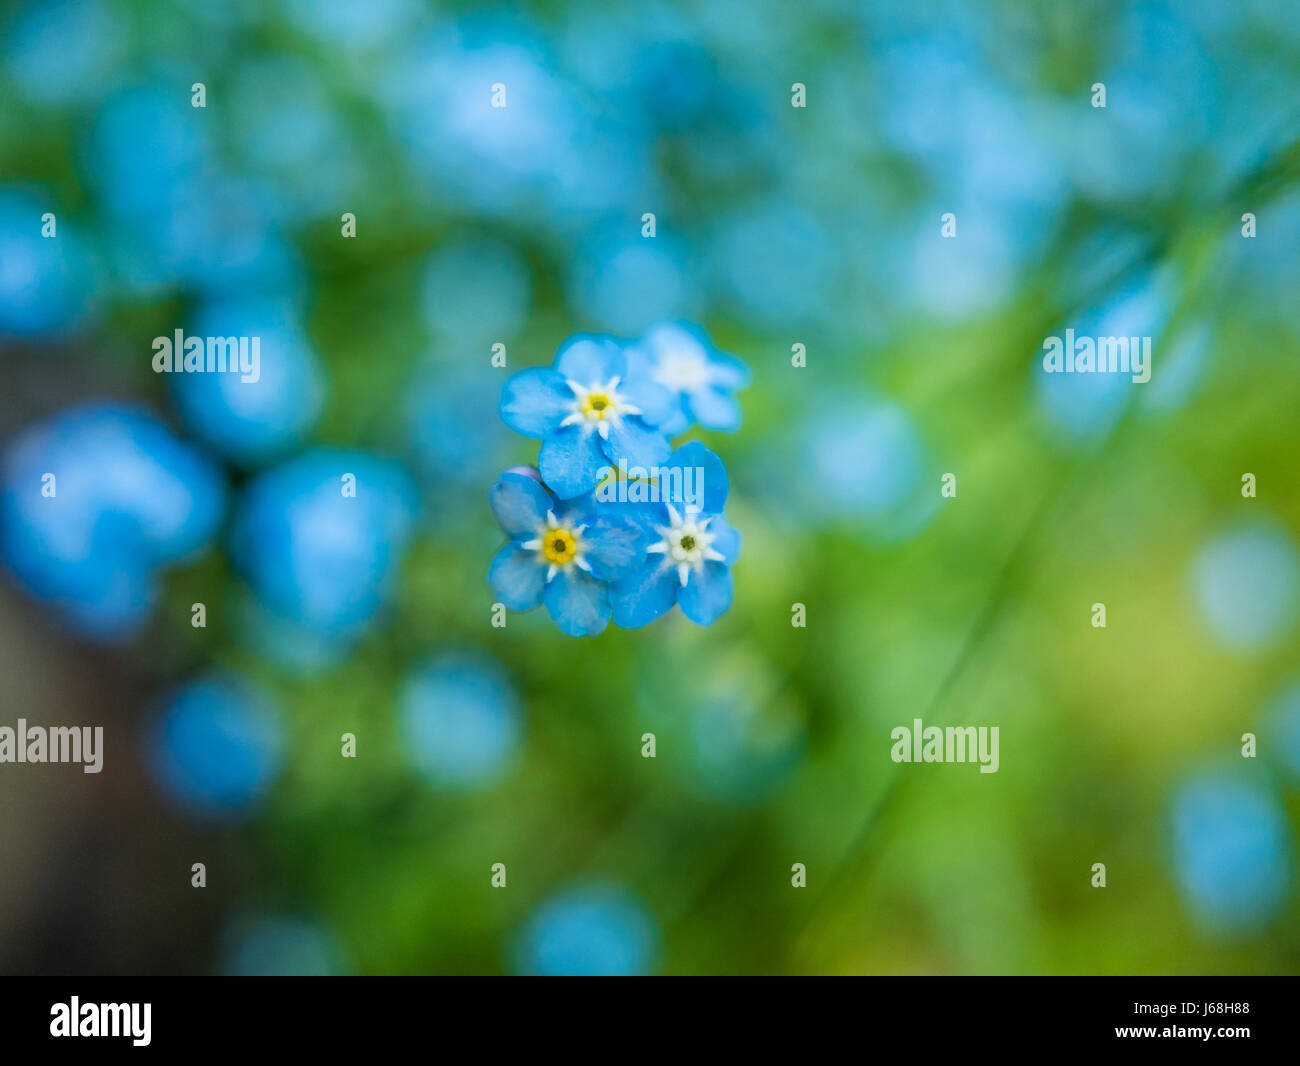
398, 653, 523, 789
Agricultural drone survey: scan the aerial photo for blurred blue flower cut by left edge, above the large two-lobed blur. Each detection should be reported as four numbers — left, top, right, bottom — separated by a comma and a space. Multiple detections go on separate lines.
0, 189, 91, 337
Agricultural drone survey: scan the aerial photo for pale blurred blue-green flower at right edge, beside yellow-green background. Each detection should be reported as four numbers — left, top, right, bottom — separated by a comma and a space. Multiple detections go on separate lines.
1191, 520, 1300, 651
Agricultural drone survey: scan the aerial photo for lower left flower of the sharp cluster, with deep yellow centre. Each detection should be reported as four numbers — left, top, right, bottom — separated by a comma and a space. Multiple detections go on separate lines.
488, 468, 638, 637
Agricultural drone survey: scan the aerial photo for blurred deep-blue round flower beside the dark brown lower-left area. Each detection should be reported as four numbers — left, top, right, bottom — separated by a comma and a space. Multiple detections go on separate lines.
148, 675, 285, 818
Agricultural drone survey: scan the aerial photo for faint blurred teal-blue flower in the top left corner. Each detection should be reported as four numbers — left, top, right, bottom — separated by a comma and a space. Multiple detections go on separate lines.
4, 0, 126, 104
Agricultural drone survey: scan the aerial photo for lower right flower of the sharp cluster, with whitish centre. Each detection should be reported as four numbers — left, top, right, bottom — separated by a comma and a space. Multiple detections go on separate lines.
602, 441, 740, 629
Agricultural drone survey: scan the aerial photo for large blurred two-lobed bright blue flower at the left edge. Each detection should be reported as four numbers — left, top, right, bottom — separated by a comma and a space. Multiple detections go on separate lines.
0, 404, 225, 641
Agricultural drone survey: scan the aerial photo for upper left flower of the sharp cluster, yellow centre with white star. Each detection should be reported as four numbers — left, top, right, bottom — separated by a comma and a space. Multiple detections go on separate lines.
501, 334, 673, 499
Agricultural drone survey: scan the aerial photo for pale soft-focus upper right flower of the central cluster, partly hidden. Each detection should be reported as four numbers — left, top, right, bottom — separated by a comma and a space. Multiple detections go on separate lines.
628, 322, 749, 437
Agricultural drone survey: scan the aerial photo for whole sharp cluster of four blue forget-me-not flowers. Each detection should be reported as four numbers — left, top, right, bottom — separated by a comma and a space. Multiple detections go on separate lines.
488, 322, 749, 637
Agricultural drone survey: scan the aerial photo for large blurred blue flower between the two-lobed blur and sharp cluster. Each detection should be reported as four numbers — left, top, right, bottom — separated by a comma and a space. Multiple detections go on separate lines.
230, 449, 416, 644
